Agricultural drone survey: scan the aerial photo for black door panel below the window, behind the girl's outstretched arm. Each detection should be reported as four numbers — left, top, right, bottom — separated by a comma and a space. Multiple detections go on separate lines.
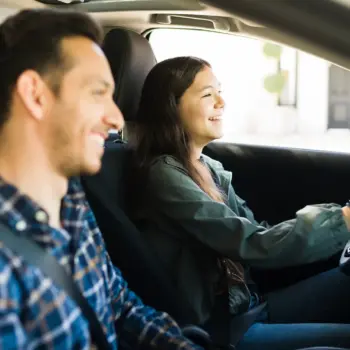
204, 143, 350, 291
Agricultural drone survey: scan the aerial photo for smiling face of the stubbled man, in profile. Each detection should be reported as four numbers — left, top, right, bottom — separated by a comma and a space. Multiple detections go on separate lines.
41, 37, 124, 177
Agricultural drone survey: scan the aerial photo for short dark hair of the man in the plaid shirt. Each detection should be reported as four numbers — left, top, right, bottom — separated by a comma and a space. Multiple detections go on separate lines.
0, 9, 103, 129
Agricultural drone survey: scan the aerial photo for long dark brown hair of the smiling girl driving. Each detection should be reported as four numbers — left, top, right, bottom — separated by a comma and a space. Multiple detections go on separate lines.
130, 57, 223, 202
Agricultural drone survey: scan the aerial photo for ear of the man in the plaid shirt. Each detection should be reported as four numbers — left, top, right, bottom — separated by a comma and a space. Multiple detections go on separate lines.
15, 70, 50, 120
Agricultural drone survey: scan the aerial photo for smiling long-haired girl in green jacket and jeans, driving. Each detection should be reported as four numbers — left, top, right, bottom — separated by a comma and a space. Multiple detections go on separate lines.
131, 57, 350, 350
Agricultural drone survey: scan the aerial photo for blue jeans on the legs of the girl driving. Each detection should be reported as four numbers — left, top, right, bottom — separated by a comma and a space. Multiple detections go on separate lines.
237, 268, 350, 350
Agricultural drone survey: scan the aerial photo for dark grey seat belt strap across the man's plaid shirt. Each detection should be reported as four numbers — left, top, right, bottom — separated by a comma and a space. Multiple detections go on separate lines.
0, 223, 111, 350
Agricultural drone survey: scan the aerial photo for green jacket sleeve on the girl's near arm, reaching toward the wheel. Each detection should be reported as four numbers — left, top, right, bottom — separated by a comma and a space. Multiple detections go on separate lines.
148, 160, 350, 268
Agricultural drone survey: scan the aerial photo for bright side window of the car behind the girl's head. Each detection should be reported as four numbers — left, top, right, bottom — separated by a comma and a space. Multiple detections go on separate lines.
150, 29, 350, 153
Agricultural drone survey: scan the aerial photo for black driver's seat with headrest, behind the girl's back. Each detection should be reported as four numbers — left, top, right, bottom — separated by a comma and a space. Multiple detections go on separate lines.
82, 28, 229, 344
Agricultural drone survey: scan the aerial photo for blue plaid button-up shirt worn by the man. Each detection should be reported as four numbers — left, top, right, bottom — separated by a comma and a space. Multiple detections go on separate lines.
0, 180, 201, 350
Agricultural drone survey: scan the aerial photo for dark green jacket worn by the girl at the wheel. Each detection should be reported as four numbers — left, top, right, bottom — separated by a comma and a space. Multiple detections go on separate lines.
137, 156, 350, 322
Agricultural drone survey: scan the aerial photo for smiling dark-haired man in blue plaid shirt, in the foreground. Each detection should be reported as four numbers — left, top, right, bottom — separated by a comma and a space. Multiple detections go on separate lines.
0, 10, 199, 349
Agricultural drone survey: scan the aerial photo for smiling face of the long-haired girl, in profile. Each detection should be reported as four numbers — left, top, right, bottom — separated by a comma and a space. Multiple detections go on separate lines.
179, 66, 225, 147
